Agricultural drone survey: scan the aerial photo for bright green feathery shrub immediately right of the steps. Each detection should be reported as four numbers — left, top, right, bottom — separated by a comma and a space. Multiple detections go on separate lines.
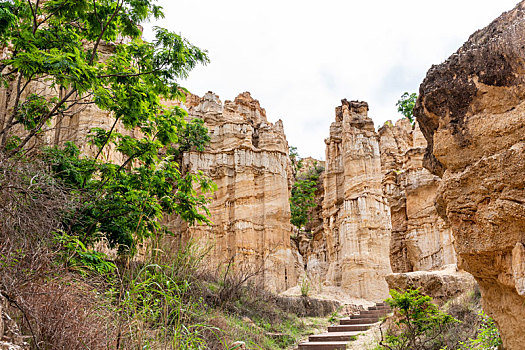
379, 289, 459, 350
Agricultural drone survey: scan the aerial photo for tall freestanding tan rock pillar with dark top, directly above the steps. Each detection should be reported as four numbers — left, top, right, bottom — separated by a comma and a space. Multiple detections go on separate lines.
306, 100, 391, 300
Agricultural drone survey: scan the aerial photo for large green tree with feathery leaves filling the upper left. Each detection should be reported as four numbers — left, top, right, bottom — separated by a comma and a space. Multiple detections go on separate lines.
0, 0, 213, 253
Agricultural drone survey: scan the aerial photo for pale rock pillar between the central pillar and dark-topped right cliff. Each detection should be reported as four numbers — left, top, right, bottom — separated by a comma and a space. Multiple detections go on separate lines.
379, 118, 456, 272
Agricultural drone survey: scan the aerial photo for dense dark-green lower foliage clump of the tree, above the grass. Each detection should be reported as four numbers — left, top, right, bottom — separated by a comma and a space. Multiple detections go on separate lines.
44, 129, 214, 254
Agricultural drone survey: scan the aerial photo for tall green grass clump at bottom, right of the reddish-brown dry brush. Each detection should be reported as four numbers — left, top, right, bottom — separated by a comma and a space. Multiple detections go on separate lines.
112, 239, 216, 350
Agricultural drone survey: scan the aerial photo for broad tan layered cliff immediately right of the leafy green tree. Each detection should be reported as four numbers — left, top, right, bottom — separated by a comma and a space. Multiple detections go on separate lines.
173, 92, 298, 291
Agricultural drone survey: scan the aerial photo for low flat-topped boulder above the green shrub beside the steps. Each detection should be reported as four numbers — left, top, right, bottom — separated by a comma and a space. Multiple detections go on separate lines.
386, 265, 476, 304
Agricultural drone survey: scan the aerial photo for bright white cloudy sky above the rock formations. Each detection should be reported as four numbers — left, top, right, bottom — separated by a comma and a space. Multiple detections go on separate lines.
144, 0, 518, 159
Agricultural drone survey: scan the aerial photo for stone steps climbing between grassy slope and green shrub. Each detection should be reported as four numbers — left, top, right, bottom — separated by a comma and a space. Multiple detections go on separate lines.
298, 303, 390, 350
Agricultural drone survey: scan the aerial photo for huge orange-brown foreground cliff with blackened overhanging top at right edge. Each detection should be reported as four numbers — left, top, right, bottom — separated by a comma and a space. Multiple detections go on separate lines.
415, 2, 525, 350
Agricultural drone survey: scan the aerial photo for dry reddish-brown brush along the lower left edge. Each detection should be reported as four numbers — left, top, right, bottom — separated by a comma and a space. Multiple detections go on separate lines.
0, 159, 113, 350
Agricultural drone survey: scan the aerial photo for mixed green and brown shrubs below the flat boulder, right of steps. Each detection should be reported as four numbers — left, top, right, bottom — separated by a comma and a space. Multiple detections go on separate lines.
377, 286, 501, 350
